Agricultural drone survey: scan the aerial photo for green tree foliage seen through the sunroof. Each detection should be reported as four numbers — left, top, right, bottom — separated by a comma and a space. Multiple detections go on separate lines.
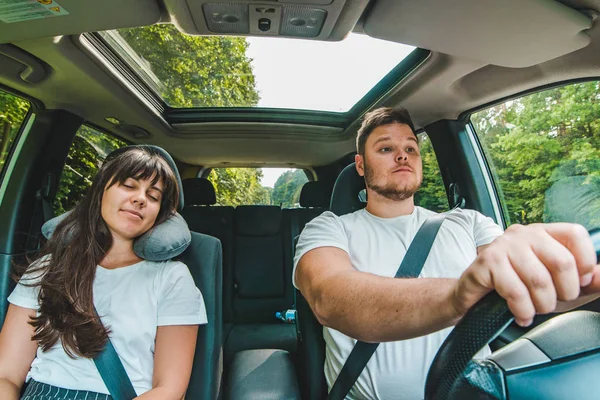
119, 24, 259, 107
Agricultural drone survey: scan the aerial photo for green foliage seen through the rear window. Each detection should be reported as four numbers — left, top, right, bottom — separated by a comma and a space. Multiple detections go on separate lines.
208, 168, 270, 207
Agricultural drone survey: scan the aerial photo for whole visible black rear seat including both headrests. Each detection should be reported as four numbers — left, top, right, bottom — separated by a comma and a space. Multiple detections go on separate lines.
181, 178, 330, 365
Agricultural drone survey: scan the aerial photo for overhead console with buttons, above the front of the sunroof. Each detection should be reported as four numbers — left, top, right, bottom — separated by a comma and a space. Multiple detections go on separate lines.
164, 0, 368, 40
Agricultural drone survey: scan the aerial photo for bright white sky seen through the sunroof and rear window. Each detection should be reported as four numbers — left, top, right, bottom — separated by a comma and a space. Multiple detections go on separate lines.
246, 34, 413, 187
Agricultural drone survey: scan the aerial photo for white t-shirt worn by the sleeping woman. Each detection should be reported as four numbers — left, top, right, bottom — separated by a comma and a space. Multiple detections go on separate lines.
8, 261, 207, 395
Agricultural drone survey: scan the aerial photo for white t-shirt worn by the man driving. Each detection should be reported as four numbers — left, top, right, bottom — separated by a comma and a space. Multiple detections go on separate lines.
292, 207, 502, 400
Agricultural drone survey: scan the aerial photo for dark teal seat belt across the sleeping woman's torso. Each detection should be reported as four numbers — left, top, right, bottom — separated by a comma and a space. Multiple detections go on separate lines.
94, 313, 137, 400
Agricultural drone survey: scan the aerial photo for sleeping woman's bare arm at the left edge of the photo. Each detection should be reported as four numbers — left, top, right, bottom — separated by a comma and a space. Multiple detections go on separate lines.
0, 304, 38, 400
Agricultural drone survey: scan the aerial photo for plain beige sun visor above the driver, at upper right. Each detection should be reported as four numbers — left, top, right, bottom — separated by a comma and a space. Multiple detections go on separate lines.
363, 0, 592, 68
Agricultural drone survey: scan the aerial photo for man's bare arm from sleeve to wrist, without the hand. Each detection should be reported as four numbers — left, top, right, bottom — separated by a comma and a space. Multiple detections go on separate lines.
296, 247, 460, 342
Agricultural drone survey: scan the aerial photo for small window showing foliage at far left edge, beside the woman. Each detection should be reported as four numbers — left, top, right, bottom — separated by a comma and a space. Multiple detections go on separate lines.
0, 90, 31, 175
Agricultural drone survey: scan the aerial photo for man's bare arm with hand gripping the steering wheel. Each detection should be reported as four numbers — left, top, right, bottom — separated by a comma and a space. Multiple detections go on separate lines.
296, 224, 600, 342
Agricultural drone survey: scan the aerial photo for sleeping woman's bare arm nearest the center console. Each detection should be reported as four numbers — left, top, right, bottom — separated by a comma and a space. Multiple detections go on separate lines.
136, 325, 198, 400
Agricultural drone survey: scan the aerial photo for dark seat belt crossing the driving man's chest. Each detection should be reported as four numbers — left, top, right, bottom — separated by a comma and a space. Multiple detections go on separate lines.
327, 210, 453, 400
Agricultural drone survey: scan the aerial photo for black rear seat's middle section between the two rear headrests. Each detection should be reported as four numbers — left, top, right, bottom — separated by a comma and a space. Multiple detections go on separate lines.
224, 206, 297, 360
